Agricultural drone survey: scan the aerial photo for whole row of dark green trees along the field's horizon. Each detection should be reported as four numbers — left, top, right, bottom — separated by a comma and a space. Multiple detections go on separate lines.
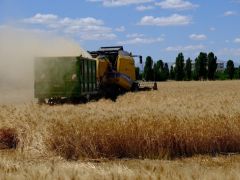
136, 52, 240, 81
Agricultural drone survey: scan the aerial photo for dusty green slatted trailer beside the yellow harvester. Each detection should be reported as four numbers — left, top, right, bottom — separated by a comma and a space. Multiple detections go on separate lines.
34, 57, 97, 99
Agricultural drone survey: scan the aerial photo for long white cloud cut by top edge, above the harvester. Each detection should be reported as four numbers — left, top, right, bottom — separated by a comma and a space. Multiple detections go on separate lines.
87, 0, 153, 7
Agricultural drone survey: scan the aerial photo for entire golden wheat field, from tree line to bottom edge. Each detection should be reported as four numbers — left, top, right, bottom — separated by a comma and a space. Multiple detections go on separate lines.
0, 81, 240, 179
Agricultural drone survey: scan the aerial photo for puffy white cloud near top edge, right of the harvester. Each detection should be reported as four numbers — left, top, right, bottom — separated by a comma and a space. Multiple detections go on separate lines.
155, 0, 199, 10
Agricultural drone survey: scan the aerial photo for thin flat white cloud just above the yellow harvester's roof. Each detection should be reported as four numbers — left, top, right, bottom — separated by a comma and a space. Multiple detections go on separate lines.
118, 37, 164, 45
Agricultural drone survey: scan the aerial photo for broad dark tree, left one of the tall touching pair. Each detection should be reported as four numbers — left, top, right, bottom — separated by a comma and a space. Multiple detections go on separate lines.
195, 52, 208, 80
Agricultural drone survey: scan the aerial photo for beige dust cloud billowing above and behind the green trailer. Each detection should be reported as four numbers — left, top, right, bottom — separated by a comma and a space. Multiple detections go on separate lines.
0, 27, 90, 104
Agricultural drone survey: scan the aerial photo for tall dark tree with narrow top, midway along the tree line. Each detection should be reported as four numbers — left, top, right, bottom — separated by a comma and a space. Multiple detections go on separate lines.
175, 53, 184, 81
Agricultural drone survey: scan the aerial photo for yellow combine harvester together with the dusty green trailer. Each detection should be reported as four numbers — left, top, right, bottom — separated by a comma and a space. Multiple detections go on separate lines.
34, 46, 157, 105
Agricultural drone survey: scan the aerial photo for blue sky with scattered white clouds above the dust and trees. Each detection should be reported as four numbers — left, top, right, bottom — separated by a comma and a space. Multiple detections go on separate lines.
0, 0, 240, 64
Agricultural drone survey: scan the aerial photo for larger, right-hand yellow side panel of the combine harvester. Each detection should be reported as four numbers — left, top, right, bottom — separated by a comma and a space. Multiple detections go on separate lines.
117, 55, 136, 81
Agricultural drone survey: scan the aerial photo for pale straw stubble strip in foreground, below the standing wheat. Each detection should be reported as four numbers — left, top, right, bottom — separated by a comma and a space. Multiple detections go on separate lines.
0, 152, 240, 180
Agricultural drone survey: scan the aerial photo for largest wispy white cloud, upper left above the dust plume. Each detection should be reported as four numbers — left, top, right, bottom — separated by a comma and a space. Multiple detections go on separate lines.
23, 14, 116, 40
